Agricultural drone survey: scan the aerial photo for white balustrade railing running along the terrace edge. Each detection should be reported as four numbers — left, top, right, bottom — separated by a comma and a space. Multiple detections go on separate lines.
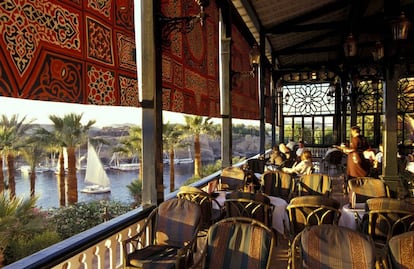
4, 149, 334, 269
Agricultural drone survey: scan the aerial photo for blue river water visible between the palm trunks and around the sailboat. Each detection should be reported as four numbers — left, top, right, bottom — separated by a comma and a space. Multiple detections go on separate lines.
13, 164, 194, 209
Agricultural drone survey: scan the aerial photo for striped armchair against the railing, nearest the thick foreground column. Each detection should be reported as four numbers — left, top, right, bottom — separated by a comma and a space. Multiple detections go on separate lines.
122, 198, 201, 269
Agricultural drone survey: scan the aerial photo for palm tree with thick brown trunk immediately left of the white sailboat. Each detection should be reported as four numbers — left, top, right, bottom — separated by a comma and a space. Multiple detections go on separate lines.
49, 113, 96, 204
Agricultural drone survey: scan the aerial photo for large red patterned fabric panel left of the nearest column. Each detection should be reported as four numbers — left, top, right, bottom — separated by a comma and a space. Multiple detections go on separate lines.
0, 0, 140, 107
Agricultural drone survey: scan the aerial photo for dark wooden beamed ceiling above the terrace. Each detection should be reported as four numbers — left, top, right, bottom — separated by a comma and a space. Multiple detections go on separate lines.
232, 0, 414, 78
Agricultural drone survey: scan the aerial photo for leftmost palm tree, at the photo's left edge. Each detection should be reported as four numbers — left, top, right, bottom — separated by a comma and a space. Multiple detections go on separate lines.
0, 114, 32, 199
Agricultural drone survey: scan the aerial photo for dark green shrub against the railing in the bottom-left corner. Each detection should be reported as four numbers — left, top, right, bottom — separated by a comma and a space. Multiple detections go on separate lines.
4, 231, 61, 264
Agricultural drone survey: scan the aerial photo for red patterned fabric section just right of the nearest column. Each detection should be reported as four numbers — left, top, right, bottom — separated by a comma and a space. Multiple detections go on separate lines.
161, 0, 220, 117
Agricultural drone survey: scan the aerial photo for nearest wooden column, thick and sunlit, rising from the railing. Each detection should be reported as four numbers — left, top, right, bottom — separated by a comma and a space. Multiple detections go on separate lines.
134, 0, 164, 206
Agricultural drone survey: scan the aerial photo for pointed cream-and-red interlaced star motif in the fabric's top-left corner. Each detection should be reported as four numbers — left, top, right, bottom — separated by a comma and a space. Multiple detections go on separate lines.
0, 0, 81, 76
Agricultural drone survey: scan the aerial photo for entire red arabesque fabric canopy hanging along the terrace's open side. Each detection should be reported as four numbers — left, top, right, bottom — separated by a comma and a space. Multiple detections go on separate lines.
0, 0, 259, 119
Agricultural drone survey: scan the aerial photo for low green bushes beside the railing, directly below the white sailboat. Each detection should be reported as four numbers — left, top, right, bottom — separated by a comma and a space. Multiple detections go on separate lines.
49, 200, 131, 239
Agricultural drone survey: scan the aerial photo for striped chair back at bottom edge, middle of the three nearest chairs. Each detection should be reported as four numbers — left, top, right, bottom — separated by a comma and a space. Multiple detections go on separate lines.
192, 217, 276, 269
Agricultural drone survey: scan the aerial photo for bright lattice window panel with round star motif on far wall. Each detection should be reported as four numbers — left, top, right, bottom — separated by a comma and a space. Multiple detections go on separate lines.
283, 83, 335, 116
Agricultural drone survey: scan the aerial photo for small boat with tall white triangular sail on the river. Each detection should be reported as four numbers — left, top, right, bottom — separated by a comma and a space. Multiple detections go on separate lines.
81, 142, 111, 193
